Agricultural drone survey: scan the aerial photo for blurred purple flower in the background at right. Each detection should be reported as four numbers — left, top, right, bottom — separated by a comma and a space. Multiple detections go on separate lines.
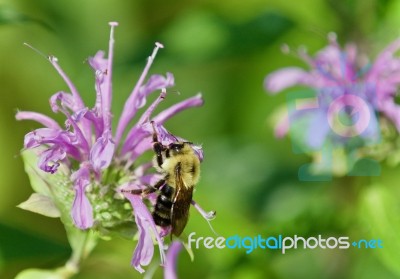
264, 34, 400, 150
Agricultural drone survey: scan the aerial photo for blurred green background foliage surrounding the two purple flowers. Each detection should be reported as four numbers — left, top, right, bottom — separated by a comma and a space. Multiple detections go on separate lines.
0, 0, 400, 279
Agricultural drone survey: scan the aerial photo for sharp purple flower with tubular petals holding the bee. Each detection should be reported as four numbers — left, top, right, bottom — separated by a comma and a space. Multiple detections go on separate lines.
16, 22, 209, 272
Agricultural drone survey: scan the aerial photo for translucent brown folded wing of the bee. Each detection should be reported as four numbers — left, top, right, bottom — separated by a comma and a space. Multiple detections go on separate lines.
171, 163, 193, 236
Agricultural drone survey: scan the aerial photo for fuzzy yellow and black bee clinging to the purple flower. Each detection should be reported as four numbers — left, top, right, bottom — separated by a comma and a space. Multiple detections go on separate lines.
131, 121, 200, 237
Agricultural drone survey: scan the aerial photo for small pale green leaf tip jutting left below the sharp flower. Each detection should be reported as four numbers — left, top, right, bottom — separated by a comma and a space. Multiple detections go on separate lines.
17, 193, 61, 218
